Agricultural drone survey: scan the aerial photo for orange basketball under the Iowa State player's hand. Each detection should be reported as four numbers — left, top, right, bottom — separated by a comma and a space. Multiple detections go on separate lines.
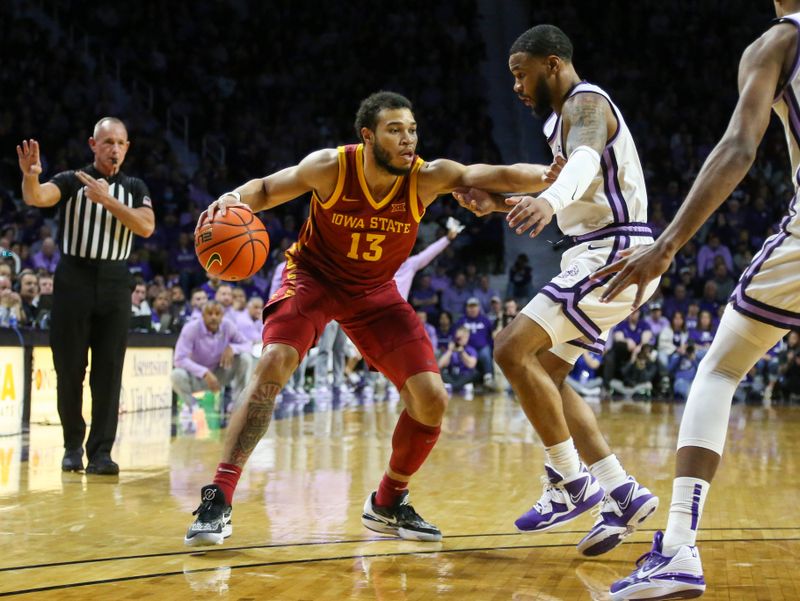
194, 207, 269, 282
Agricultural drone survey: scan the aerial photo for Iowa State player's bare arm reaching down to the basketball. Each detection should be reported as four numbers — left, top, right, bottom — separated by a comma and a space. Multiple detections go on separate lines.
198, 148, 339, 225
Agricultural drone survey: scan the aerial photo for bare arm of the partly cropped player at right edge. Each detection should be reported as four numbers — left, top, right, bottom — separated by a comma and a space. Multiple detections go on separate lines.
594, 24, 797, 307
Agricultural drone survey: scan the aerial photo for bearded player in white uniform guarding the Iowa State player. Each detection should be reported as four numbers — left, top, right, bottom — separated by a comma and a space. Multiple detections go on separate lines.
456, 25, 658, 555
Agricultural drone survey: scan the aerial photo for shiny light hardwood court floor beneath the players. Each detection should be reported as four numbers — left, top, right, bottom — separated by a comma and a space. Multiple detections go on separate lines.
0, 395, 800, 601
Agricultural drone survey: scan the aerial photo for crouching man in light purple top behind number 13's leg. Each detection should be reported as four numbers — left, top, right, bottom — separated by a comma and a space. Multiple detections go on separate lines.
172, 301, 252, 405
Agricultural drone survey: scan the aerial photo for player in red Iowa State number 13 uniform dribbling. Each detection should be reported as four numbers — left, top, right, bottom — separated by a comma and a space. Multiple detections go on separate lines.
184, 92, 560, 546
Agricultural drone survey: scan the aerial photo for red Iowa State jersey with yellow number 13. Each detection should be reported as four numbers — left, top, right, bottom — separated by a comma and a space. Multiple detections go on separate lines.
286, 144, 425, 293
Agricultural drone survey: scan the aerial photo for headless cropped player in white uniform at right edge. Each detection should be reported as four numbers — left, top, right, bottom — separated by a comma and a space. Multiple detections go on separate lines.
597, 0, 800, 600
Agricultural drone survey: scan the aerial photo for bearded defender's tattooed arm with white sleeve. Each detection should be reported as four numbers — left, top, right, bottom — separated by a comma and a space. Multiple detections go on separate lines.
506, 92, 619, 238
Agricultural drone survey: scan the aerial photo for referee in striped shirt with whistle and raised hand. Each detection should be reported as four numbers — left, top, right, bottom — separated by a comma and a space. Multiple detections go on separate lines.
17, 117, 155, 475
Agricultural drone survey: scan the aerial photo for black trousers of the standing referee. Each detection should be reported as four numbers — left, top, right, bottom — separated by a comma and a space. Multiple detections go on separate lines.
50, 256, 131, 461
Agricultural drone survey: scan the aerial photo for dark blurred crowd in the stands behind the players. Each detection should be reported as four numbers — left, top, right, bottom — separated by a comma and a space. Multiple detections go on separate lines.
0, 0, 800, 401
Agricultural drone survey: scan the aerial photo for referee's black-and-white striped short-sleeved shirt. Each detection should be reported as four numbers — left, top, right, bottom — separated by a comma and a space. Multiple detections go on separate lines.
50, 165, 153, 261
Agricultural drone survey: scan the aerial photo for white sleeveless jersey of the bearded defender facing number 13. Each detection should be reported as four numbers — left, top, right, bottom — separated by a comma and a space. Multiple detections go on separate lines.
544, 82, 647, 236
